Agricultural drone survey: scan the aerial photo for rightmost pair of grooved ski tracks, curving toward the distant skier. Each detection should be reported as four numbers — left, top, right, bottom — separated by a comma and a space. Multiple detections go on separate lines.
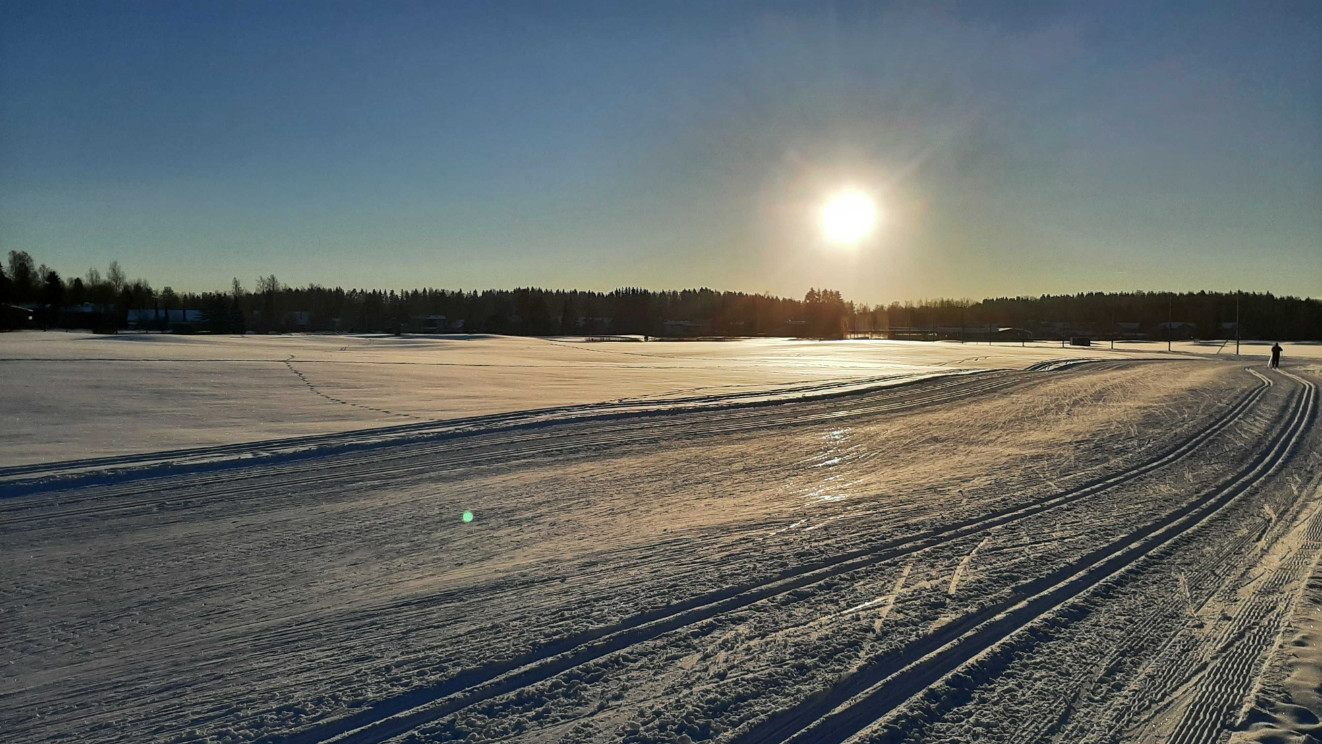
734, 375, 1315, 744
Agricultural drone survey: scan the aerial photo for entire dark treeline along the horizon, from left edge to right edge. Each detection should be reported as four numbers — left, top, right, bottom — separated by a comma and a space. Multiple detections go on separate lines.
0, 251, 1322, 341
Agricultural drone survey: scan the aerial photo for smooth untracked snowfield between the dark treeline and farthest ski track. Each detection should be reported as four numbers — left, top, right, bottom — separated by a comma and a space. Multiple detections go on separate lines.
0, 332, 1319, 466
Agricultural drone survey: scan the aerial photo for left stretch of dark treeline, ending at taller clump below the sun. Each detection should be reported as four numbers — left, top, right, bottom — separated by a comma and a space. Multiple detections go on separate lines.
0, 251, 861, 337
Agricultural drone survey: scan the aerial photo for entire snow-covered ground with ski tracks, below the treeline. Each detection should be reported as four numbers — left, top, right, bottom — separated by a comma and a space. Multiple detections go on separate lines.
0, 334, 1322, 744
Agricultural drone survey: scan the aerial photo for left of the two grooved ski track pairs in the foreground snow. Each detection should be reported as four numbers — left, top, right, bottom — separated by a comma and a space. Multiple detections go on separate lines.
252, 370, 1272, 744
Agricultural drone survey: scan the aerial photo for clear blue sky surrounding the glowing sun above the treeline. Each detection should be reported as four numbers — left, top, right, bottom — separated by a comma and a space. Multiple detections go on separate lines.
0, 0, 1322, 303
